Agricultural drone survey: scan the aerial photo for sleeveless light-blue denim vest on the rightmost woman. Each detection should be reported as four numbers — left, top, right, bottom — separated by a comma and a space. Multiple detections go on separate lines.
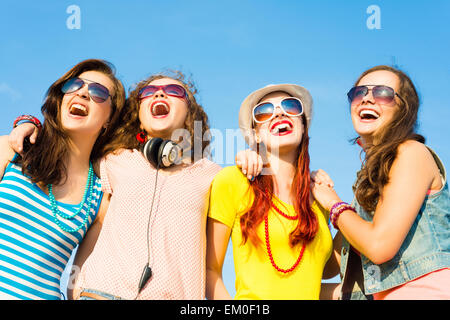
341, 148, 450, 299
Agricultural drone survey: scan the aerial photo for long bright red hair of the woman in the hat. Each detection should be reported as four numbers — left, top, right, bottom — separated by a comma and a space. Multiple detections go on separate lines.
240, 116, 318, 247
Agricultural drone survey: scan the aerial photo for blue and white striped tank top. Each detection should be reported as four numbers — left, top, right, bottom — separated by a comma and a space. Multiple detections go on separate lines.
0, 157, 103, 300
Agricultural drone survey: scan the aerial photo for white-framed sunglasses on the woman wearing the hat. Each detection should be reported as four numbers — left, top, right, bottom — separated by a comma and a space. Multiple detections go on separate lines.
252, 97, 303, 123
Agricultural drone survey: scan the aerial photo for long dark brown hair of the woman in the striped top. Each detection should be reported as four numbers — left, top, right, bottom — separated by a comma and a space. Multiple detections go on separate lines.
16, 59, 125, 185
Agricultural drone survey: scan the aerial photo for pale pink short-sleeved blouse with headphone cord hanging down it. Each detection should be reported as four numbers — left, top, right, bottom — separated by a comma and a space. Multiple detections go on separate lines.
78, 150, 221, 300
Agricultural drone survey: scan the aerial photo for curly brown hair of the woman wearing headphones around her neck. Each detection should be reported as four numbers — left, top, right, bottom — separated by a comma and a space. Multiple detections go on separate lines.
109, 70, 210, 162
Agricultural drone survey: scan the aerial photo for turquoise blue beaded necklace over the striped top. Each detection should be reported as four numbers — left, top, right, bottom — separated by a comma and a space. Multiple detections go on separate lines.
47, 162, 94, 233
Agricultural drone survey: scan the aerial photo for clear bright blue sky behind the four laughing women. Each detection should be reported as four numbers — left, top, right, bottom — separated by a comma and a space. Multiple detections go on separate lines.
0, 0, 450, 294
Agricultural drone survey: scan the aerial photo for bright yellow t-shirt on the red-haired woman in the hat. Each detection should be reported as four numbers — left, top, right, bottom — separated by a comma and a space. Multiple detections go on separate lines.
208, 166, 332, 300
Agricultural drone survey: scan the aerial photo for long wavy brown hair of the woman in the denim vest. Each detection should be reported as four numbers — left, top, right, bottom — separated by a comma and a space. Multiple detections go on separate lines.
353, 65, 425, 213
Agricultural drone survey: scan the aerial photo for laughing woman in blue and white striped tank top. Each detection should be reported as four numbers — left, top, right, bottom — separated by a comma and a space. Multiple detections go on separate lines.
0, 59, 125, 300
